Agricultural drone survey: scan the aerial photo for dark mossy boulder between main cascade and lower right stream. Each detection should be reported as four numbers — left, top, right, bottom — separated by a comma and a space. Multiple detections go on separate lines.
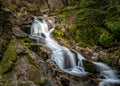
83, 60, 97, 74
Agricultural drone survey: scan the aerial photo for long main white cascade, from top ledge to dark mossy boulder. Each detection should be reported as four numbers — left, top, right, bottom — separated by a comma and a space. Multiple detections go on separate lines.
31, 17, 86, 75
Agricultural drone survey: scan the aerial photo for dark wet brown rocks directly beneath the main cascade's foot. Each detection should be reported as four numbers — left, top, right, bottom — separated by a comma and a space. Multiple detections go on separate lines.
47, 61, 100, 86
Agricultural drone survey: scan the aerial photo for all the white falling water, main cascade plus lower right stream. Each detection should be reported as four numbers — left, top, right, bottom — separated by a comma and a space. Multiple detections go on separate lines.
31, 17, 120, 86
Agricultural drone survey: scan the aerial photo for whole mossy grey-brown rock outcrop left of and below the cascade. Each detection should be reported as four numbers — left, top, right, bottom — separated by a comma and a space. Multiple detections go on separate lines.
0, 26, 99, 86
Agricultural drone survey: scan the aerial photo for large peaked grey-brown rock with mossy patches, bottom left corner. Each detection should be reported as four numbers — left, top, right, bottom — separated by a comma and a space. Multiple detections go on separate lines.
0, 42, 47, 86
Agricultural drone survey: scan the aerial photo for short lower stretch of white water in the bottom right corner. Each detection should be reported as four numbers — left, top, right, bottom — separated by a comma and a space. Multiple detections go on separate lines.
93, 62, 120, 86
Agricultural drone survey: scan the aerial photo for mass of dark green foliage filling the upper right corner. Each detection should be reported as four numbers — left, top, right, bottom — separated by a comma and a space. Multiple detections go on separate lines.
76, 0, 120, 48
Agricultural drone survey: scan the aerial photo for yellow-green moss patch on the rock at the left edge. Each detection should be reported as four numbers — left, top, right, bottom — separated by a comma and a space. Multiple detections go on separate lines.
0, 41, 17, 74
